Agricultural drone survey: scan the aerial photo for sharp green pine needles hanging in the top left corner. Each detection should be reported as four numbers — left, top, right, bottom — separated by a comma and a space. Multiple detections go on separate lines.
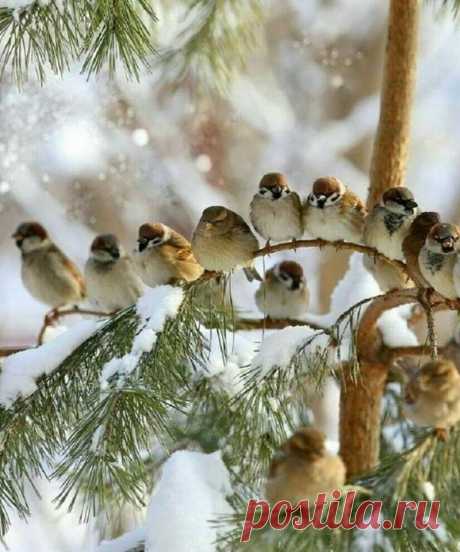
0, 0, 155, 84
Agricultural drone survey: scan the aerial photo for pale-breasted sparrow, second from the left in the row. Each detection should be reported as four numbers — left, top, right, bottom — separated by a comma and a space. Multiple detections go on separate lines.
85, 234, 144, 312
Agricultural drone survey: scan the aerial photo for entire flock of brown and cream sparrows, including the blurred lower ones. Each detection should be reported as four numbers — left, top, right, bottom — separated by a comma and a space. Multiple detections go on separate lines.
13, 173, 460, 500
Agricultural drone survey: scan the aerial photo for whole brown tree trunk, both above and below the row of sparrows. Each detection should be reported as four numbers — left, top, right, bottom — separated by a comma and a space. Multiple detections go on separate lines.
340, 0, 420, 479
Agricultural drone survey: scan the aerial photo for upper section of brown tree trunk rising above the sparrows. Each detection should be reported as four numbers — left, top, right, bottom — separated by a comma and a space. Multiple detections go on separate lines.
367, 0, 420, 208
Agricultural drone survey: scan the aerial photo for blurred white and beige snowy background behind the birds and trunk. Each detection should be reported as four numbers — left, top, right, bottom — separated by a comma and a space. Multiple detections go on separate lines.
0, 0, 460, 552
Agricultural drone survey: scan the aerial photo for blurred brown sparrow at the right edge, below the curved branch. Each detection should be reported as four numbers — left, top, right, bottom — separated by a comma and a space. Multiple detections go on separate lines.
404, 360, 460, 429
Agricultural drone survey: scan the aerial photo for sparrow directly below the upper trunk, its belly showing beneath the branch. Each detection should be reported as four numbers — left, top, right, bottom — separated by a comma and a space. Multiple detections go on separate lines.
364, 186, 417, 291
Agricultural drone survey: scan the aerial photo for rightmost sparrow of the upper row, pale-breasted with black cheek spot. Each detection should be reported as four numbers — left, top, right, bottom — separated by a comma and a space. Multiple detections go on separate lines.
418, 224, 460, 299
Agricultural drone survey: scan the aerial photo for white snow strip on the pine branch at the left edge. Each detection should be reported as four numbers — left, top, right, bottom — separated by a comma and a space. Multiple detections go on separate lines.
0, 320, 101, 408
